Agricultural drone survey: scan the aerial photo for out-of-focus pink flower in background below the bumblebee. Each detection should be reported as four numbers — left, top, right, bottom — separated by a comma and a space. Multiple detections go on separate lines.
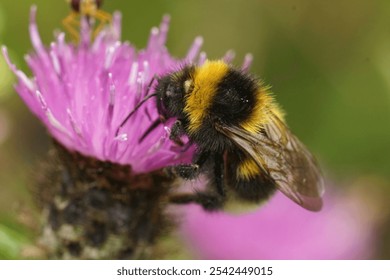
182, 187, 375, 259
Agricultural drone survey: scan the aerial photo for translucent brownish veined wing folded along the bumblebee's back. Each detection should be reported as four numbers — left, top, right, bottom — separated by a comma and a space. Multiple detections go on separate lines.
217, 114, 324, 211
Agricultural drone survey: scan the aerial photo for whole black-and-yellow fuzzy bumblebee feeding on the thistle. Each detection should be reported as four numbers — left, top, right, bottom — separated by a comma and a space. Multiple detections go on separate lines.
118, 61, 323, 211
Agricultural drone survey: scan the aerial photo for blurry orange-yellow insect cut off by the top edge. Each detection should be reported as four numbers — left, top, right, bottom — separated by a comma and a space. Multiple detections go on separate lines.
62, 0, 112, 41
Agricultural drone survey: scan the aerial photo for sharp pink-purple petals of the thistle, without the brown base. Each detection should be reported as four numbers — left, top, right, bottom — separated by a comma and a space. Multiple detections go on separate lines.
3, 7, 206, 172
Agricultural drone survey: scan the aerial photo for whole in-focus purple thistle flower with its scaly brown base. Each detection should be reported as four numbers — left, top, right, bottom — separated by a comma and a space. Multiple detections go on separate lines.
2, 4, 278, 259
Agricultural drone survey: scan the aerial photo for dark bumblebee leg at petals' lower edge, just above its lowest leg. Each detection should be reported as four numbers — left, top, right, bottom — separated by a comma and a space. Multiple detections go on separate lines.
166, 152, 210, 180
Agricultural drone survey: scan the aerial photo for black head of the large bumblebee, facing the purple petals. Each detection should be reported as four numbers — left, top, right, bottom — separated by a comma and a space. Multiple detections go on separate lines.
155, 67, 193, 119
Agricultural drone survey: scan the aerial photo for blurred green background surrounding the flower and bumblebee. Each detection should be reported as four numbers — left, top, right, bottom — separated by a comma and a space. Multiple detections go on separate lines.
0, 0, 390, 259
